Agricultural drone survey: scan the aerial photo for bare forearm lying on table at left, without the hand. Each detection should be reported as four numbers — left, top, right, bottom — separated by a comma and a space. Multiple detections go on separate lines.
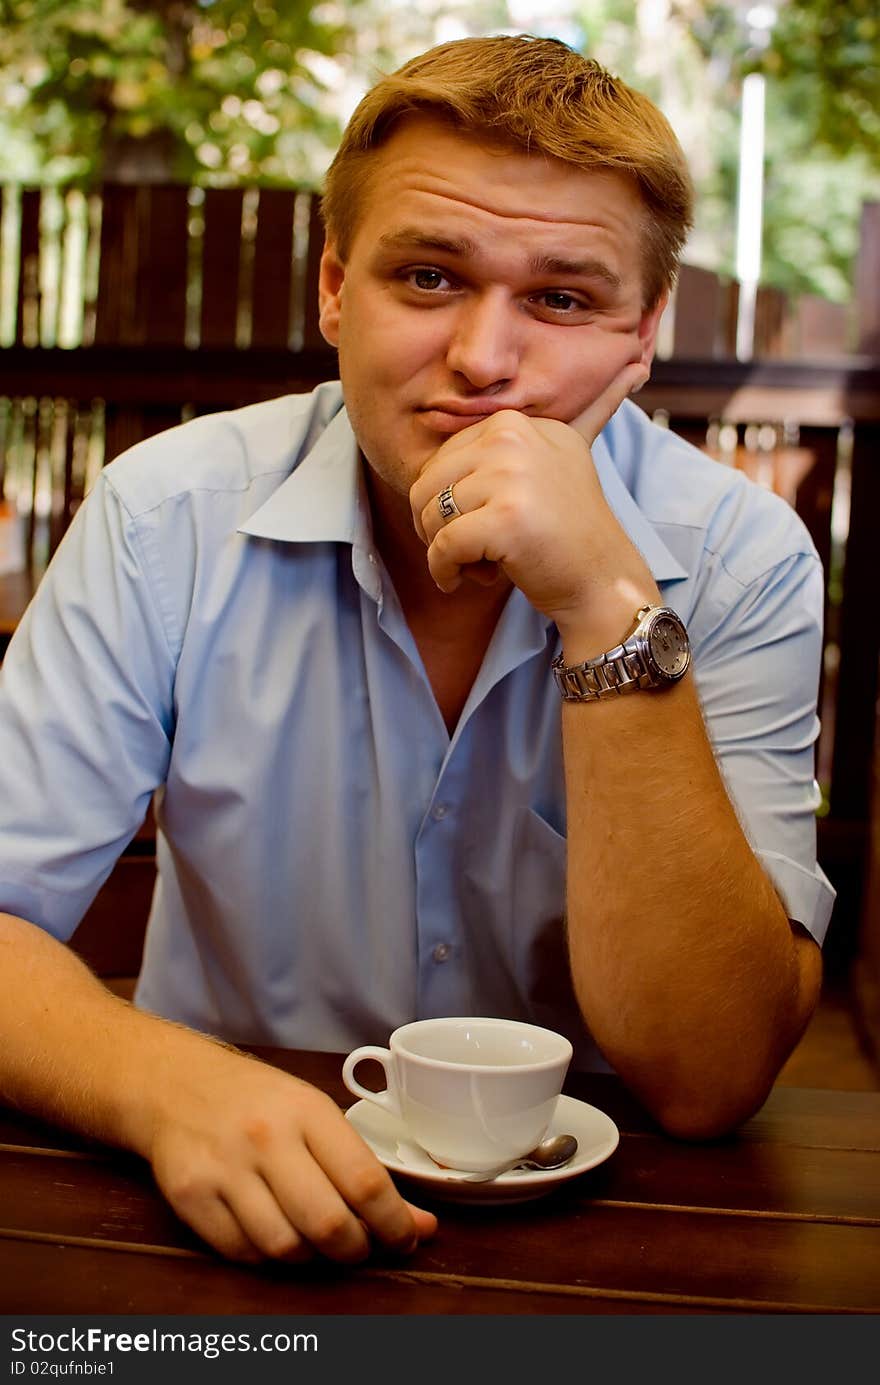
0, 914, 230, 1156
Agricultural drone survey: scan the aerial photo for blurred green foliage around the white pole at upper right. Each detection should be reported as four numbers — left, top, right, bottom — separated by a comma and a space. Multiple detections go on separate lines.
672, 0, 880, 303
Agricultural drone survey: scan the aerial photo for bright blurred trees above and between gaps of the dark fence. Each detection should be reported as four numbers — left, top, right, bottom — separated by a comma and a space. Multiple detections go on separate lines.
0, 0, 880, 359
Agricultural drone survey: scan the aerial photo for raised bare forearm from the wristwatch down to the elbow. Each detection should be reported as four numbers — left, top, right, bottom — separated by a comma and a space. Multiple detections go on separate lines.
563, 677, 819, 1134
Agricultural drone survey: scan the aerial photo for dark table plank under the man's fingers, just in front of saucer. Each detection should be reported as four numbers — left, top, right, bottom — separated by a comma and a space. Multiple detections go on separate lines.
0, 1151, 880, 1312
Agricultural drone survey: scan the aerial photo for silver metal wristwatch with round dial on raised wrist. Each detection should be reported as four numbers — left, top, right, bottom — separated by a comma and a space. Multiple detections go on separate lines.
552, 605, 690, 702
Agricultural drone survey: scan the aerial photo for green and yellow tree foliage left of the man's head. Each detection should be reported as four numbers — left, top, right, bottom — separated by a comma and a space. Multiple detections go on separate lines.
0, 0, 356, 183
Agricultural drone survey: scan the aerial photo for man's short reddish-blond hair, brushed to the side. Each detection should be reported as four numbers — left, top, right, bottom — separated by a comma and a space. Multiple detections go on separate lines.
322, 35, 693, 307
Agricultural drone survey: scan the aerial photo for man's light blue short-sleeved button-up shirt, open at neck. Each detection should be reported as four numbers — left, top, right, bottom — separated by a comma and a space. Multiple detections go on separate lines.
0, 384, 833, 1065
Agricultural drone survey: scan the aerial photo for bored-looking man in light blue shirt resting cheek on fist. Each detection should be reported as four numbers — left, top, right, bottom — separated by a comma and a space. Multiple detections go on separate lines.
0, 37, 831, 1260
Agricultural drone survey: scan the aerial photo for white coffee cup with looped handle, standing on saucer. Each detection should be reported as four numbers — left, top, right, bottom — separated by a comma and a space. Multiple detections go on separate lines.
342, 1017, 572, 1172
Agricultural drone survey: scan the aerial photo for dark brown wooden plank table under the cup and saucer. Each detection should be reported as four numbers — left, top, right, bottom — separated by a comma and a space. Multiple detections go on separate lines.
0, 1050, 880, 1314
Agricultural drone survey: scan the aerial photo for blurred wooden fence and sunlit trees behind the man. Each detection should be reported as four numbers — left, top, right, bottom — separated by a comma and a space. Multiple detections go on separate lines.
0, 0, 880, 1086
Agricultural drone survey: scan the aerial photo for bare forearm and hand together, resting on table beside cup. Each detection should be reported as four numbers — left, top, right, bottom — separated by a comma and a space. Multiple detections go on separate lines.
0, 914, 437, 1262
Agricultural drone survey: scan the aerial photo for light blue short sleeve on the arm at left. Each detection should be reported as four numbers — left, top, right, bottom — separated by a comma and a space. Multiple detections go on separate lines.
0, 475, 175, 938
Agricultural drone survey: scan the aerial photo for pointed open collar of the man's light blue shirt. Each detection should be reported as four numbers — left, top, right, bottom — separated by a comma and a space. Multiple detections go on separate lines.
238, 396, 687, 583
